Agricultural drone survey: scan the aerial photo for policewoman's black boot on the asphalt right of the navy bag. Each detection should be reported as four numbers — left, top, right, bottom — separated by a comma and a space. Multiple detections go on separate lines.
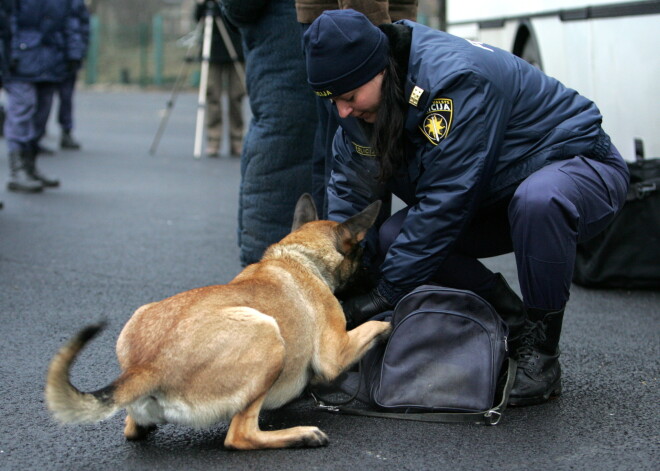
509, 309, 564, 406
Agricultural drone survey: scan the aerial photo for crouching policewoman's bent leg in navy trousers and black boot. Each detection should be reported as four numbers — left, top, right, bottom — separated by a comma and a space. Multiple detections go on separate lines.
509, 146, 628, 405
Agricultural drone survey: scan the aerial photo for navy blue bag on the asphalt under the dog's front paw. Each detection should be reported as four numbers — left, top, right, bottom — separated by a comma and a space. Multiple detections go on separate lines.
319, 285, 516, 425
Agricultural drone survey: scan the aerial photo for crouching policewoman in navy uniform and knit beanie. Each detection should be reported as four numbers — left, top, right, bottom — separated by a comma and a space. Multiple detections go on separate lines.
304, 10, 629, 405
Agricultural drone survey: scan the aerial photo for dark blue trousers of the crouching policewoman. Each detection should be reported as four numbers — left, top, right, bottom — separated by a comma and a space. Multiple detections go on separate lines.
379, 146, 629, 310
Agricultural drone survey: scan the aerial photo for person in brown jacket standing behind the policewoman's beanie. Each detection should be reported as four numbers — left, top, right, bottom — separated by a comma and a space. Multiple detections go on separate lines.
296, 0, 418, 219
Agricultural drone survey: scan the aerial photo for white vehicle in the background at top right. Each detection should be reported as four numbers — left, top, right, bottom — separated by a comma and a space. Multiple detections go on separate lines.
447, 0, 660, 160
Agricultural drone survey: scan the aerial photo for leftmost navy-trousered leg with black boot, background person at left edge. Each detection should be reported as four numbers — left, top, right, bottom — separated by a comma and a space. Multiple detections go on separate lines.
4, 81, 43, 193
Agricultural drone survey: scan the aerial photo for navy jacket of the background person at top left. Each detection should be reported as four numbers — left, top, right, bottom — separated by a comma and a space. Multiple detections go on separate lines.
9, 0, 85, 82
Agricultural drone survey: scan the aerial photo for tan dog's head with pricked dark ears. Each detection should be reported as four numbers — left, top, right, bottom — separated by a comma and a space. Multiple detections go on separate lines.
269, 194, 381, 291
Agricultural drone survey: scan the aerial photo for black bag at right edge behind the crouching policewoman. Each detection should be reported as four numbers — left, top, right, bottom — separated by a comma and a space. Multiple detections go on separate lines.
573, 155, 660, 289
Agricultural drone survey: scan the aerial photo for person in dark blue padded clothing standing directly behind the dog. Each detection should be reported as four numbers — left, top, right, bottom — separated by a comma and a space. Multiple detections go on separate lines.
222, 0, 316, 265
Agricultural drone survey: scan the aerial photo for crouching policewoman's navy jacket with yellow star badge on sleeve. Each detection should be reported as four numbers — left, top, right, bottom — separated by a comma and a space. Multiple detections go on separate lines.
328, 21, 610, 302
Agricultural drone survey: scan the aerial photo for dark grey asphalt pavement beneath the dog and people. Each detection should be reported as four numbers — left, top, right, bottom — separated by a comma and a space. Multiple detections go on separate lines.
0, 90, 660, 471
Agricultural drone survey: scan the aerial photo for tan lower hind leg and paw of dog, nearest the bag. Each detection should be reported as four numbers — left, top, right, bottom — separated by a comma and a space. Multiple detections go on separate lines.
225, 394, 328, 450
